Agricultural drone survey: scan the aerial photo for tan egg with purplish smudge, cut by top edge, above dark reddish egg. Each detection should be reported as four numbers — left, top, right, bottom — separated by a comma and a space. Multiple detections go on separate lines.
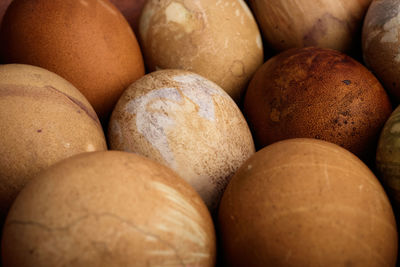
249, 0, 371, 52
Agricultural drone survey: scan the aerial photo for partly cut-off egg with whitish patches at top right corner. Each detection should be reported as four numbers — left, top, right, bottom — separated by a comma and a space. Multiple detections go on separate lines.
362, 0, 400, 102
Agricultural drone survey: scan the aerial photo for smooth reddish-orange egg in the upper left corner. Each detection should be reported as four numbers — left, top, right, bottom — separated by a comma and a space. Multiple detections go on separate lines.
1, 0, 144, 121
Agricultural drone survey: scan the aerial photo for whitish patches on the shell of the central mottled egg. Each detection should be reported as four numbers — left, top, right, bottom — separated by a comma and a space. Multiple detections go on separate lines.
125, 74, 229, 170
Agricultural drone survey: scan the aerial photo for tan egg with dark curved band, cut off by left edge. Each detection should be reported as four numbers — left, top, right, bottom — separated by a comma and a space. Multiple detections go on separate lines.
0, 64, 107, 224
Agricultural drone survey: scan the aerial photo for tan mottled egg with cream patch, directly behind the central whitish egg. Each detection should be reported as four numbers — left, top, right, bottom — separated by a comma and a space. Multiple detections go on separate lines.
139, 0, 263, 102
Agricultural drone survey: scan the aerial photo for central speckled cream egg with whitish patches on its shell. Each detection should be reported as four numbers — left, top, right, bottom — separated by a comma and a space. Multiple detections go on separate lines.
108, 70, 254, 211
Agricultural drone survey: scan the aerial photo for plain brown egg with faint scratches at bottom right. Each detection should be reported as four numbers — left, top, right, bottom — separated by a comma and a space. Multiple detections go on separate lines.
219, 139, 398, 267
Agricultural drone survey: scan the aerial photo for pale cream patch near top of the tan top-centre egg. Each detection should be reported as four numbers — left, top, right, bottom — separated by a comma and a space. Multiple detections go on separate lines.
165, 2, 194, 33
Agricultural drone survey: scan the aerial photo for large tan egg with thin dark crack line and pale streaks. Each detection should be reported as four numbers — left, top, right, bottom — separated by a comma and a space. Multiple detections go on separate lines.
2, 151, 215, 267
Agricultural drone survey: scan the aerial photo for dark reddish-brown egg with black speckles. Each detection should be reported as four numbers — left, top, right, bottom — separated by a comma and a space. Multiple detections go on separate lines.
244, 48, 391, 160
